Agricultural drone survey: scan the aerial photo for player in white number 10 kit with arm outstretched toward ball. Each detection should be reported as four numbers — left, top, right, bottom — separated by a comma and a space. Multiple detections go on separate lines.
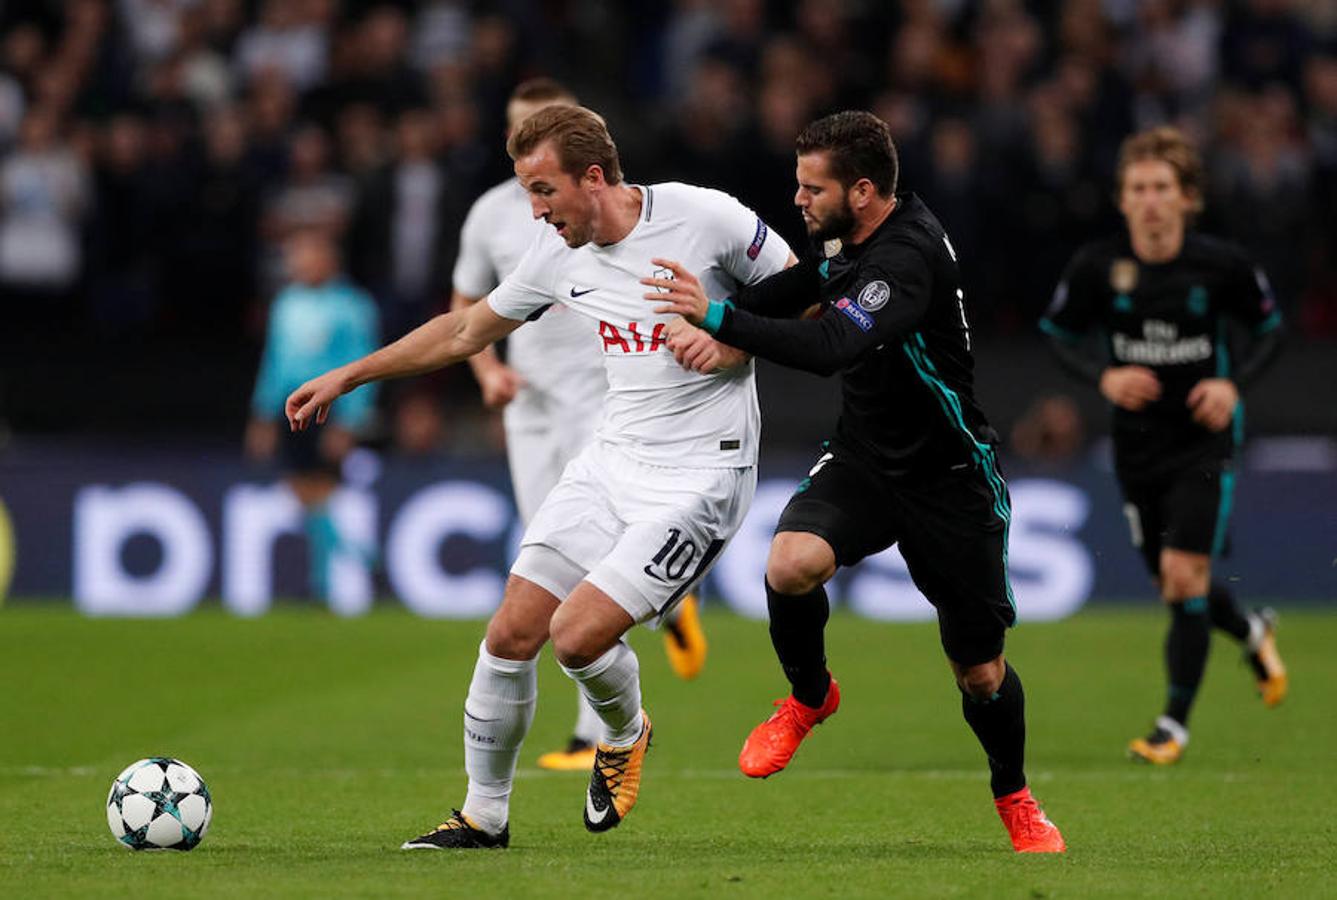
286, 106, 794, 849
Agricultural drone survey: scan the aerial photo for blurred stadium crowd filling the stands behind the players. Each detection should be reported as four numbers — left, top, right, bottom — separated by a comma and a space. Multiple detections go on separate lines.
0, 0, 1337, 433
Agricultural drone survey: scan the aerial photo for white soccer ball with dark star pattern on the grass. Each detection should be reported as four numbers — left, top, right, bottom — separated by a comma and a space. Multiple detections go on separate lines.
107, 757, 214, 851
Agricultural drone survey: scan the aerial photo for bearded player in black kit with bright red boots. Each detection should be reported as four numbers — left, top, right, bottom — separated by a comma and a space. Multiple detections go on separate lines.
643, 112, 1064, 853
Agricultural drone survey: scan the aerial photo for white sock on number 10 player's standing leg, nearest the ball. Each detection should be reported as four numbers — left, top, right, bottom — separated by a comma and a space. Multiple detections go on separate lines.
460, 643, 539, 833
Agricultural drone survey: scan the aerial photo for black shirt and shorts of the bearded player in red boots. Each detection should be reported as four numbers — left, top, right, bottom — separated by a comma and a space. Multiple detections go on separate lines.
715, 194, 1016, 665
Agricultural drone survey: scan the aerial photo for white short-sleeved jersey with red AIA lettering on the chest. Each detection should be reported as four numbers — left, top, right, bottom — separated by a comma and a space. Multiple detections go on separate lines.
488, 183, 789, 468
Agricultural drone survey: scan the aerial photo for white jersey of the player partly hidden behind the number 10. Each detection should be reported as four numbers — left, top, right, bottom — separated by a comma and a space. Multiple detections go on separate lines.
452, 178, 602, 388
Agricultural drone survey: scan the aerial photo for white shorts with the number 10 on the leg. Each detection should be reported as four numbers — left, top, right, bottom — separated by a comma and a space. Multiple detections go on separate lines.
511, 440, 757, 622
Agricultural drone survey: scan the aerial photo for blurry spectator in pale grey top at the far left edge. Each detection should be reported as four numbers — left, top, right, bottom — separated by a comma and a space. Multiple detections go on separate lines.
0, 107, 90, 302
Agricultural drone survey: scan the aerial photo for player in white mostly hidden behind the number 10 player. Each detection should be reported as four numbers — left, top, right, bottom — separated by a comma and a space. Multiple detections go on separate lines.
451, 78, 706, 770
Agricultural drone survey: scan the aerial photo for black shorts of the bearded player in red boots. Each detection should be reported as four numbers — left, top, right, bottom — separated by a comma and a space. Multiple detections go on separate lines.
775, 443, 1016, 666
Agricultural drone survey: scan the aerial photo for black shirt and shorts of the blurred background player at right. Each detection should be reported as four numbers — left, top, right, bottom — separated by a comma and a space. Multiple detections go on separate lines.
1040, 233, 1281, 574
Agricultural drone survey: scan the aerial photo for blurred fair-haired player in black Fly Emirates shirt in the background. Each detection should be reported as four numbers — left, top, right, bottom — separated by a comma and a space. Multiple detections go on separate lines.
1040, 127, 1286, 764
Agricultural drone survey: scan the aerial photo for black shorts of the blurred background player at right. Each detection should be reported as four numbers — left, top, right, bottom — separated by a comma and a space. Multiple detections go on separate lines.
1119, 459, 1235, 576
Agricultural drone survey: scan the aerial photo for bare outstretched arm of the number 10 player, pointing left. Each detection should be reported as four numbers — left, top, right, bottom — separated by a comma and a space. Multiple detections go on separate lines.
283, 304, 524, 431
